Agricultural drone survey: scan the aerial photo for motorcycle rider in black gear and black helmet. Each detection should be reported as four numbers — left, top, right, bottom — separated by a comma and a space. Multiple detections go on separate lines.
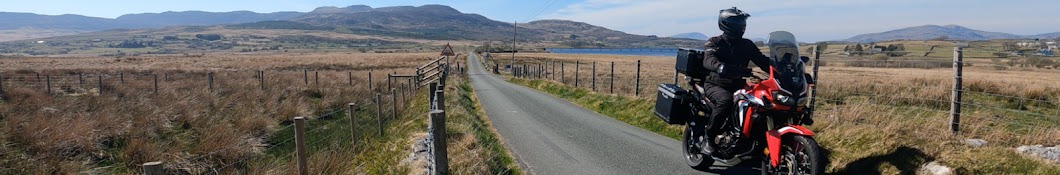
702, 7, 770, 153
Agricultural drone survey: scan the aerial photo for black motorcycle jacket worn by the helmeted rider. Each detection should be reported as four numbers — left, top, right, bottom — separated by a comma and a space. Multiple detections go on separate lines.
703, 34, 770, 88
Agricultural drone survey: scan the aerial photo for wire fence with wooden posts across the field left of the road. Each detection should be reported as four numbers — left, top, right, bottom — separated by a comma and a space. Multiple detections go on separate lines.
0, 65, 438, 174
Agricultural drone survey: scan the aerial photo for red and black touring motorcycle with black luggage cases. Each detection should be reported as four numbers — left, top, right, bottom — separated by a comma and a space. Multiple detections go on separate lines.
655, 31, 827, 174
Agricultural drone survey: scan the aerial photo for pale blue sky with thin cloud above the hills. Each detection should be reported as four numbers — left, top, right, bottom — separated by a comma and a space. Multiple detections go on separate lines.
0, 0, 1060, 41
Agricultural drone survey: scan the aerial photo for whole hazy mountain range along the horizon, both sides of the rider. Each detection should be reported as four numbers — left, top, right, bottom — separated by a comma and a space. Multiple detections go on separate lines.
0, 5, 1060, 47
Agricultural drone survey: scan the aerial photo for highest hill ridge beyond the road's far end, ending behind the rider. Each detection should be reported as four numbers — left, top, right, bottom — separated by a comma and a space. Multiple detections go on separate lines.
286, 5, 702, 47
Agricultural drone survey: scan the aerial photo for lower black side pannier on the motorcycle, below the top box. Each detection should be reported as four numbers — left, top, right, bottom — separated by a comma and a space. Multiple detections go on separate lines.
655, 84, 692, 124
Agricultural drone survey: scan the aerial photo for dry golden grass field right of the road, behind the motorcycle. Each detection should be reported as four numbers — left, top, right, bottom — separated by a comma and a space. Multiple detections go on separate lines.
494, 54, 1060, 174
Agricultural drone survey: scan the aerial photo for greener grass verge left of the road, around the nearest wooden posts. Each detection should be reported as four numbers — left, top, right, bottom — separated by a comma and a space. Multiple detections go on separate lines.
262, 72, 522, 175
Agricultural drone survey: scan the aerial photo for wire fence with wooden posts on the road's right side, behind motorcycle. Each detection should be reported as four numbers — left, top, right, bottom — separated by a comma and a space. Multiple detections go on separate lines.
483, 47, 1060, 144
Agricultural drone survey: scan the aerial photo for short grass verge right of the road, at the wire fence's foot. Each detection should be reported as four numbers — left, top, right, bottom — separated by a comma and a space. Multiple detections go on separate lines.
508, 78, 1060, 174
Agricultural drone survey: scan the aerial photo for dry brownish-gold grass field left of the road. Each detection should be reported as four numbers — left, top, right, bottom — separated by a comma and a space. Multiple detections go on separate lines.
0, 53, 436, 174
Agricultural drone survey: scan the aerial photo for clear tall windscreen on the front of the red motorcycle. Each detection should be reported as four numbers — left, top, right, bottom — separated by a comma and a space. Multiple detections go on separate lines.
766, 31, 807, 97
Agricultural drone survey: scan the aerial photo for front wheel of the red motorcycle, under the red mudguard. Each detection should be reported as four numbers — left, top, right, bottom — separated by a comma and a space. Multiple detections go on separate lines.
761, 136, 825, 175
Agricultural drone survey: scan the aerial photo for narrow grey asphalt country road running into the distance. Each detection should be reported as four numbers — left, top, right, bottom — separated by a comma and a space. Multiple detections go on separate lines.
467, 54, 758, 175
